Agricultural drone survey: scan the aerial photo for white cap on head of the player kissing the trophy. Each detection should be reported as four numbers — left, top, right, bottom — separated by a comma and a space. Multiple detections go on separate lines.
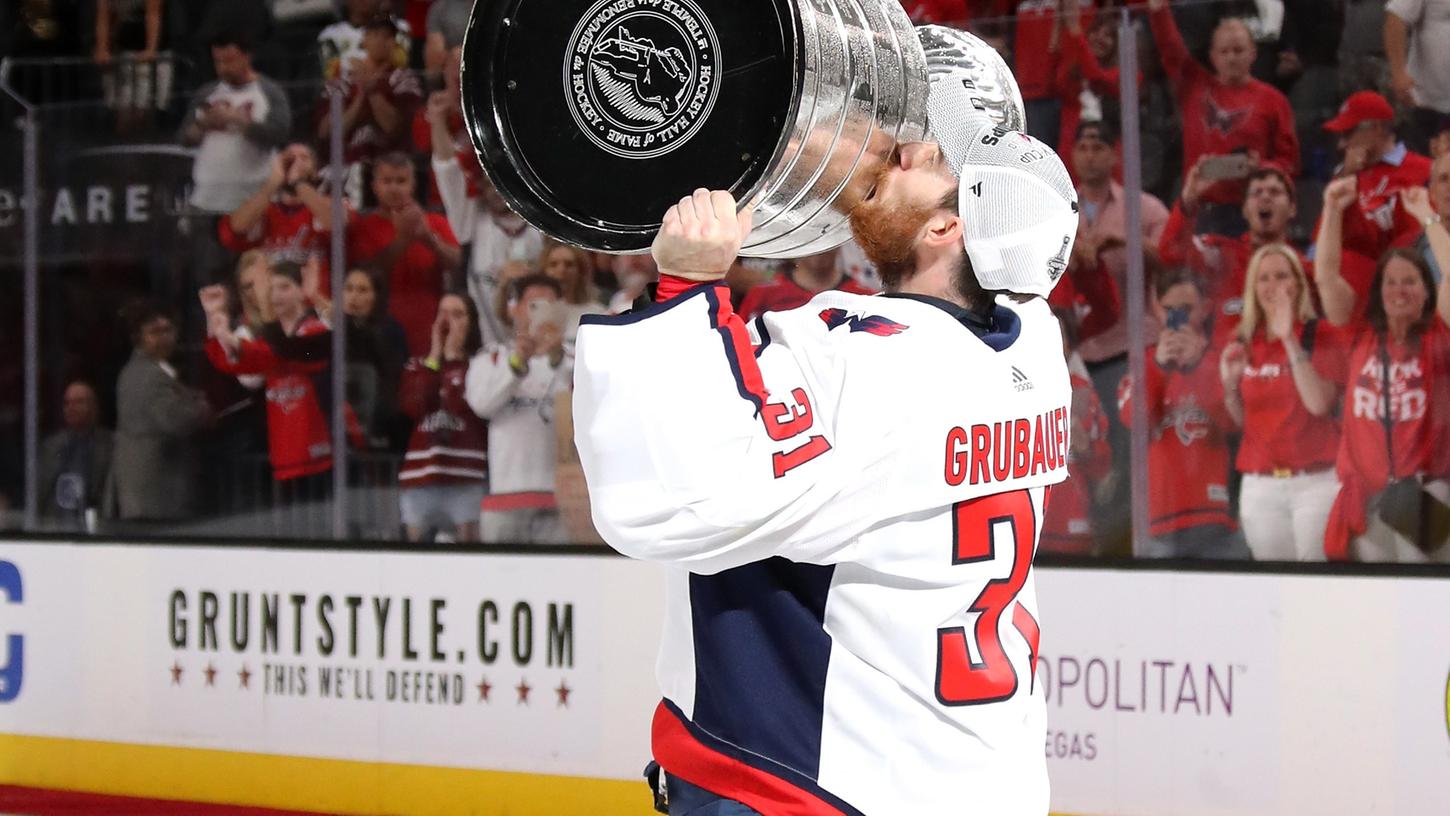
943, 125, 1077, 297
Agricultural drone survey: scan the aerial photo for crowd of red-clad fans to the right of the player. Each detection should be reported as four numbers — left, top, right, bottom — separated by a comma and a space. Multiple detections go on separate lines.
1038, 0, 1450, 561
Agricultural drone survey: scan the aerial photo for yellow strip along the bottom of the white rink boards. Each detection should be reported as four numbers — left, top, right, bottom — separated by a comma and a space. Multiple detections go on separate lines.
0, 733, 1090, 816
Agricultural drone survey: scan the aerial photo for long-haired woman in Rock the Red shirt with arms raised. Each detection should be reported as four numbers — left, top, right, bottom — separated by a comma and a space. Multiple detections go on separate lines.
1320, 190, 1450, 562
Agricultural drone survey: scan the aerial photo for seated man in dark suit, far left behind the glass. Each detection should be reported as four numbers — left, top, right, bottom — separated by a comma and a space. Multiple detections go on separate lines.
41, 380, 115, 529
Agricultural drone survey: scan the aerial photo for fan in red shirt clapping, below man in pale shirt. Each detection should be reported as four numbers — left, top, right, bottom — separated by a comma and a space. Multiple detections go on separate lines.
218, 142, 342, 287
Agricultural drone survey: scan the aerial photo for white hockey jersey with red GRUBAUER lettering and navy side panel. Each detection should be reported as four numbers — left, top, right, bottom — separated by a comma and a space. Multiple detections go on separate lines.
574, 286, 1070, 816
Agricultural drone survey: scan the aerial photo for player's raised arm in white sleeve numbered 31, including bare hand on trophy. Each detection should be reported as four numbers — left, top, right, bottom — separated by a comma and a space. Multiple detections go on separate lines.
574, 191, 860, 573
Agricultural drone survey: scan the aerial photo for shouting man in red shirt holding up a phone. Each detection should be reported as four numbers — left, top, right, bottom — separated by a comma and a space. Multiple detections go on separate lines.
1159, 167, 1311, 345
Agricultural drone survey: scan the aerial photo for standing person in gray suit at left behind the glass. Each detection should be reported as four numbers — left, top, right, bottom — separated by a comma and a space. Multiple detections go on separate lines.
112, 303, 212, 520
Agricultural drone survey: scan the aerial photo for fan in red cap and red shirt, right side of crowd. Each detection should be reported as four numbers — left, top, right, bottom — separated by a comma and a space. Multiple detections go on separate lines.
1324, 91, 1430, 266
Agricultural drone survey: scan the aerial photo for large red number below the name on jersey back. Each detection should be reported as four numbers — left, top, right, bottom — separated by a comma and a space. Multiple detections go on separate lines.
937, 490, 1038, 706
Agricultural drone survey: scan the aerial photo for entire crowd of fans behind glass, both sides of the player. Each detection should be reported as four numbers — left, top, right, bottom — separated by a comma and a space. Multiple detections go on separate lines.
8, 0, 1450, 561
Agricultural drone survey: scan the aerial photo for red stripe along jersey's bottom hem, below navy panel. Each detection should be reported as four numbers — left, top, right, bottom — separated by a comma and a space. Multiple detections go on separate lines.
651, 703, 850, 816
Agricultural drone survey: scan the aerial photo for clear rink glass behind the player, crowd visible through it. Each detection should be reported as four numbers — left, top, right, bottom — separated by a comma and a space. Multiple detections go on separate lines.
0, 0, 1450, 562
